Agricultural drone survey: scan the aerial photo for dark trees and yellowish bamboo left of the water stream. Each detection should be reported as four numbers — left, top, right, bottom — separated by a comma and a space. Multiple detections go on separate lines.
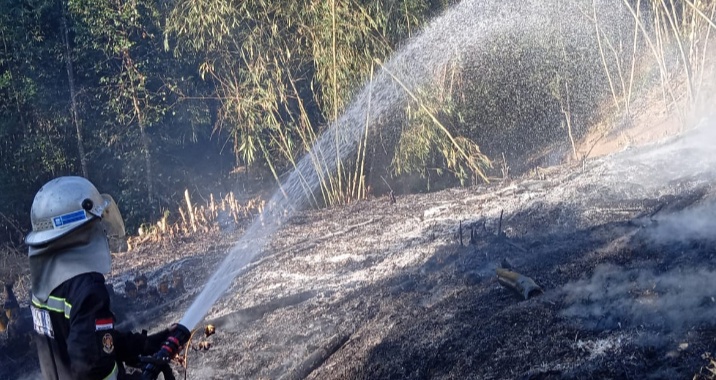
0, 0, 446, 240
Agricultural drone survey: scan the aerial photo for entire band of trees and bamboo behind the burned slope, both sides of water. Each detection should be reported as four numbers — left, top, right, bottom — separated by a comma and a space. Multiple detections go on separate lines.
0, 0, 714, 242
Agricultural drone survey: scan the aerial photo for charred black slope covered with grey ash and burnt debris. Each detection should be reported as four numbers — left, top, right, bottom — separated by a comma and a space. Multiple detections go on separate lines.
0, 123, 716, 379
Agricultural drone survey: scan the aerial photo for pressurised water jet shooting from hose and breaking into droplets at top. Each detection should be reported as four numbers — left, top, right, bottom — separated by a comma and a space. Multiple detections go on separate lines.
181, 0, 618, 329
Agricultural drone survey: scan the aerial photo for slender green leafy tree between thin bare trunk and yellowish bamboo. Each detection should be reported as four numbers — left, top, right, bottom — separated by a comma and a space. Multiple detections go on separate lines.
69, 0, 178, 218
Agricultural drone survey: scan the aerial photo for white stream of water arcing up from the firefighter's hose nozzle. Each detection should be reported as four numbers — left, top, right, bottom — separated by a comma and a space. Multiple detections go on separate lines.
165, 0, 636, 372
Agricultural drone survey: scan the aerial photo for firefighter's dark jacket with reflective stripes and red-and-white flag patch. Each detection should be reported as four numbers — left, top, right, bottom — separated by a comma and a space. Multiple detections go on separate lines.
31, 273, 147, 380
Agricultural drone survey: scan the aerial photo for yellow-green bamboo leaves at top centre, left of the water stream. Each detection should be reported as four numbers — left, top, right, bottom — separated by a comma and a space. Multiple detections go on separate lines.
167, 0, 440, 203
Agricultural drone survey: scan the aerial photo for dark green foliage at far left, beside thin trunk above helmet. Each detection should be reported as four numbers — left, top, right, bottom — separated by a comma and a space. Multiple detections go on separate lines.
0, 0, 75, 233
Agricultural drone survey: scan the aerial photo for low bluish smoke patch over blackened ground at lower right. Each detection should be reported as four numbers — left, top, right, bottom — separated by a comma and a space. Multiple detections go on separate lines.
562, 265, 716, 332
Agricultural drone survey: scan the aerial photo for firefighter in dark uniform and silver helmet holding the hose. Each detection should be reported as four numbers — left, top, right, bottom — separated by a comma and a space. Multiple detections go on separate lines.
25, 177, 176, 380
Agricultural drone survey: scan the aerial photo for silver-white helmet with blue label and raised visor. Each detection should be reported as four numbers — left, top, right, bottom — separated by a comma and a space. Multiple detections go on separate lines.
25, 177, 124, 246
